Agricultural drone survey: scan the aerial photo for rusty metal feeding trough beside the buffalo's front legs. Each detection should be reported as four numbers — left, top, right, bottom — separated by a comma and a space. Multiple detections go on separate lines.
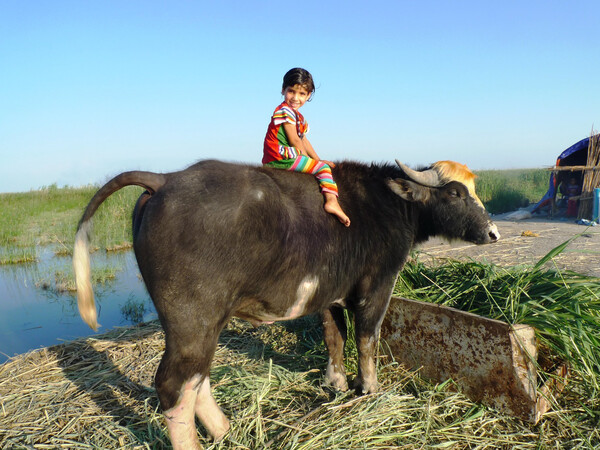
381, 297, 567, 423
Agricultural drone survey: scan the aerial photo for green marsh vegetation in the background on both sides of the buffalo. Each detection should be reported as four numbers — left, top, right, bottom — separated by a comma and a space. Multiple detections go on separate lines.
0, 169, 549, 264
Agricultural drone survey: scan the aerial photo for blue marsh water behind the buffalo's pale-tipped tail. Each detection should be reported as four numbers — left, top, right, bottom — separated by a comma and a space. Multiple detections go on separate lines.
0, 248, 156, 364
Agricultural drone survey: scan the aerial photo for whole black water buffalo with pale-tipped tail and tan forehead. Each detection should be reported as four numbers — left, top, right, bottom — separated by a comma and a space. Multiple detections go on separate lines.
73, 161, 499, 448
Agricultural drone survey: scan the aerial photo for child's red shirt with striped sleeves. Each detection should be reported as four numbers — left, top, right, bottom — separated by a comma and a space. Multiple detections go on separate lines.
262, 102, 308, 164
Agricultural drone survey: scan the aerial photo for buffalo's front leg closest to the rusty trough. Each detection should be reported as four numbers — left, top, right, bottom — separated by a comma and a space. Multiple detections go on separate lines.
354, 288, 390, 394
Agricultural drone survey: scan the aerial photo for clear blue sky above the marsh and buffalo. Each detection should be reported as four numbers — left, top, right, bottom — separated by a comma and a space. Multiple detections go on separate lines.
0, 0, 600, 192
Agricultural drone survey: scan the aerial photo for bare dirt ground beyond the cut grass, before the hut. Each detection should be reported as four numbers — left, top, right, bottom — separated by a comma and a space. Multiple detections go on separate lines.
418, 214, 600, 277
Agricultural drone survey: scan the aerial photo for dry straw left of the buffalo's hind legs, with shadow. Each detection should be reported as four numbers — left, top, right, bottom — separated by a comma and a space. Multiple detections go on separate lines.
0, 323, 168, 448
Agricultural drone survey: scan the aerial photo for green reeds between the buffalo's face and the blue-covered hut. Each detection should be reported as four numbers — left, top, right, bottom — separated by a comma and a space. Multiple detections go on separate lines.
475, 169, 550, 214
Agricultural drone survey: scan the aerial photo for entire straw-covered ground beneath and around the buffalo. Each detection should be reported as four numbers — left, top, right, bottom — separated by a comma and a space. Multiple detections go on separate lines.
0, 318, 600, 449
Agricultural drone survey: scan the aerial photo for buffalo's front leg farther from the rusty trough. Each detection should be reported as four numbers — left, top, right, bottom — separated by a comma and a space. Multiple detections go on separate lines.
321, 306, 348, 391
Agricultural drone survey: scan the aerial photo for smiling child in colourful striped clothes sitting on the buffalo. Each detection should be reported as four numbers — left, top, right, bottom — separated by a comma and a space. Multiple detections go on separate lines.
262, 68, 350, 227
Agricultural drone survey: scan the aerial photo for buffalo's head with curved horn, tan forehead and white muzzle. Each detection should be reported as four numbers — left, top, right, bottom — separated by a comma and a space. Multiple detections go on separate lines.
390, 160, 500, 244
